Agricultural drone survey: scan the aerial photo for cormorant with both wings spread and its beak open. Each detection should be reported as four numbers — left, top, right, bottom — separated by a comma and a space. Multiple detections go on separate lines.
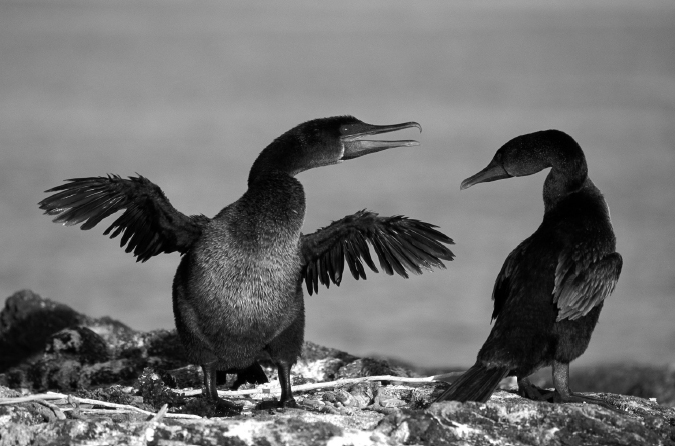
39, 116, 453, 411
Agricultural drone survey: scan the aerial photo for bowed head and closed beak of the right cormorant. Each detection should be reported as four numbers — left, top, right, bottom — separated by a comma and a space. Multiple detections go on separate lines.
460, 130, 587, 189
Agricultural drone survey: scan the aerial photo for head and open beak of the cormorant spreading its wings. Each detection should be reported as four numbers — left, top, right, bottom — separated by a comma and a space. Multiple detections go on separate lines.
249, 116, 422, 181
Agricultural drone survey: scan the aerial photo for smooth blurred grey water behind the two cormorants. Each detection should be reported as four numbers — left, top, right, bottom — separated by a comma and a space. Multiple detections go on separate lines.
0, 0, 675, 366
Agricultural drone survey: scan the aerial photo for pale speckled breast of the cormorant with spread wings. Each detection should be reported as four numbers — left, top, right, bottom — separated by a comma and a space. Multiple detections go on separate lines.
182, 220, 302, 334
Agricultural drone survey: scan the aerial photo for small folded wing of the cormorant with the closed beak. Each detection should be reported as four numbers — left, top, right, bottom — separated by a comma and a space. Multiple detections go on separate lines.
553, 251, 623, 321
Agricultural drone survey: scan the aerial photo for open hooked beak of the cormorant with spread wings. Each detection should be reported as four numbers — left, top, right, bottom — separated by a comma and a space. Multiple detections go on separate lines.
340, 122, 422, 160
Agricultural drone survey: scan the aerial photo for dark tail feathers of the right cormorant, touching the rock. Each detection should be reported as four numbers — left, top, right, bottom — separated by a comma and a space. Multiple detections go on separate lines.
435, 363, 509, 403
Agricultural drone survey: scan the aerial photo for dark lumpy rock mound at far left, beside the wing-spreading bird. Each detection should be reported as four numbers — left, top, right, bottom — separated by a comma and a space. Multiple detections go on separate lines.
0, 291, 189, 391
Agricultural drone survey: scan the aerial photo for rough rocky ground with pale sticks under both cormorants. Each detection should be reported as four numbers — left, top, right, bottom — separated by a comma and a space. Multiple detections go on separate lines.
0, 291, 675, 446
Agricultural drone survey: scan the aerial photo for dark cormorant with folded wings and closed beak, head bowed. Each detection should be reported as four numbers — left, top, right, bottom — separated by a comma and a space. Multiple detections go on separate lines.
436, 130, 622, 408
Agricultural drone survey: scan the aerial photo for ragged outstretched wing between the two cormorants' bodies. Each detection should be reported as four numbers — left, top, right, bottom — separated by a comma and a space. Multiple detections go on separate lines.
300, 210, 454, 295
